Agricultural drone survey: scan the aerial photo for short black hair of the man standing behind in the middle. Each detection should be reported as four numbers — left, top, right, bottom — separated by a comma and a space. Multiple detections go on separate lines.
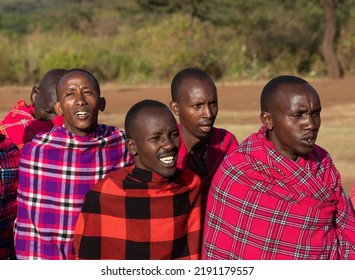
171, 68, 217, 102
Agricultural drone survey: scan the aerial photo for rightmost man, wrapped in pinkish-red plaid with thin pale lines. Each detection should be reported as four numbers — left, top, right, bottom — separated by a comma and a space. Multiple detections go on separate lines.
202, 76, 355, 260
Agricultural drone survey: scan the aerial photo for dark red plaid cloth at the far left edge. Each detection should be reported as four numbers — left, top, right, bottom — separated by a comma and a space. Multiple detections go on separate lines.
0, 134, 20, 259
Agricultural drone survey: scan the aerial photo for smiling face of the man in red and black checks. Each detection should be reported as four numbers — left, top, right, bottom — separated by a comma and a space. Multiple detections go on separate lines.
127, 108, 180, 178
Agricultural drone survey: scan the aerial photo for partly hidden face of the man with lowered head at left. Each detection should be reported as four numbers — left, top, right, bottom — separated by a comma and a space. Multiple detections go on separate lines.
31, 85, 57, 121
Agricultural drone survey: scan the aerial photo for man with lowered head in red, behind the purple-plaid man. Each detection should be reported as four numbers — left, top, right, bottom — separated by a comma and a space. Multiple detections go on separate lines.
0, 69, 65, 151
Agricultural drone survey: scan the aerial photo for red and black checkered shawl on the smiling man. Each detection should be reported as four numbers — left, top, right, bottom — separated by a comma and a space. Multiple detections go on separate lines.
73, 166, 201, 260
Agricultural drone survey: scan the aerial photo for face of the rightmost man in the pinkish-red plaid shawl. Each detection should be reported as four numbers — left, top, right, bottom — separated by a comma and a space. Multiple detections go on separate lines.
262, 84, 321, 160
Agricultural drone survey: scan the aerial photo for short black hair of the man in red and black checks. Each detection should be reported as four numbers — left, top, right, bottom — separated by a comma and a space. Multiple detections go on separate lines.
124, 99, 174, 139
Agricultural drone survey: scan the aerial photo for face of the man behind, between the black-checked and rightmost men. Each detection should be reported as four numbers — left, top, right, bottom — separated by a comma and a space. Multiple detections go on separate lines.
170, 78, 218, 145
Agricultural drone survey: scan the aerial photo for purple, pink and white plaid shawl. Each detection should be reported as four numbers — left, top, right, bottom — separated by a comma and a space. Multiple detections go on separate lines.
15, 125, 133, 259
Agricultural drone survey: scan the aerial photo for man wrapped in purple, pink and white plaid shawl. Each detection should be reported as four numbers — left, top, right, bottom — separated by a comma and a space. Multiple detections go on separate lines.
15, 69, 132, 259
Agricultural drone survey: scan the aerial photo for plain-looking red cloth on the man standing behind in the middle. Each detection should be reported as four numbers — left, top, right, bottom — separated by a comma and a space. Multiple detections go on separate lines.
176, 125, 238, 205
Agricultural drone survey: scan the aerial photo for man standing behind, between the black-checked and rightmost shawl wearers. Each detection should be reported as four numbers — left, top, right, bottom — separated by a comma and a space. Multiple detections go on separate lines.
170, 68, 238, 205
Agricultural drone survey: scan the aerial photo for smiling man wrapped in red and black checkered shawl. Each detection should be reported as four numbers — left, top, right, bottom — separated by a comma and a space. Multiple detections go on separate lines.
74, 100, 201, 260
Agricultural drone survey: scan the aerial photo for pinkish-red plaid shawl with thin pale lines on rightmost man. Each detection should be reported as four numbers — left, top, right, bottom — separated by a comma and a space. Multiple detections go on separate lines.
202, 127, 355, 260
